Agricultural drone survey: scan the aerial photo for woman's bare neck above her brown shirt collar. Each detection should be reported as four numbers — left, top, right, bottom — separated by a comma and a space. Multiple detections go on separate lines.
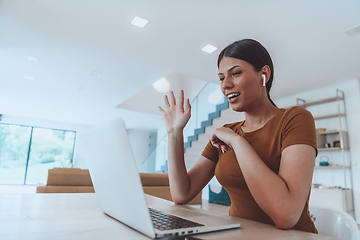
243, 99, 278, 130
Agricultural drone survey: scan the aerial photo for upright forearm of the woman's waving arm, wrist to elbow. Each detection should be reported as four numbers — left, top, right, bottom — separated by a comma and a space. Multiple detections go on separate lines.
168, 130, 190, 203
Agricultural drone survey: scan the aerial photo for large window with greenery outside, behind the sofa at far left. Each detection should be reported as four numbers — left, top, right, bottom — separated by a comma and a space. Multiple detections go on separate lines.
0, 124, 76, 184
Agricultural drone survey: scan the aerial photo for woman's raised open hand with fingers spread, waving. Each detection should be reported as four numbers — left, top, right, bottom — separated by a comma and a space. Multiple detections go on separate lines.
158, 90, 191, 133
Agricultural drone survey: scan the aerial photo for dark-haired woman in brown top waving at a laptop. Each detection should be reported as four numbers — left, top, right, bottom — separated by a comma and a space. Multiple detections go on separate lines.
159, 39, 317, 233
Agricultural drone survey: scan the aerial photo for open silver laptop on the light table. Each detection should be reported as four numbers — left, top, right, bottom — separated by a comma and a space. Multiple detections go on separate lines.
80, 119, 240, 238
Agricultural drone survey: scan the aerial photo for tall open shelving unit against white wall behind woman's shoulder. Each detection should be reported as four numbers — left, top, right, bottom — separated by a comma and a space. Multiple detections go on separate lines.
296, 89, 354, 216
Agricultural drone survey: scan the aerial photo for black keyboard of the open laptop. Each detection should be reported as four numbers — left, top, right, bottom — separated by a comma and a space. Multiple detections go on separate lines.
149, 208, 204, 231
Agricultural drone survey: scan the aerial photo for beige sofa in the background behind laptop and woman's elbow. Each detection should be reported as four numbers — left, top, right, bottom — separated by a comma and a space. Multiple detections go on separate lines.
36, 168, 202, 204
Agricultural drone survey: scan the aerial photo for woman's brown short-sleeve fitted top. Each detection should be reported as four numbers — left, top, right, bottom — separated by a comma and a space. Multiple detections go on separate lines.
202, 107, 317, 233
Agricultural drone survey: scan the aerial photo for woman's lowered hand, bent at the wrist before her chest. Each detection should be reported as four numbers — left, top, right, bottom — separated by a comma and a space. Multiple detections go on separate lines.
210, 127, 240, 153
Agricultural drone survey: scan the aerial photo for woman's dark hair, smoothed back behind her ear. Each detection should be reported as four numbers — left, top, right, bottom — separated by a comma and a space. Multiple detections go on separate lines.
218, 39, 276, 107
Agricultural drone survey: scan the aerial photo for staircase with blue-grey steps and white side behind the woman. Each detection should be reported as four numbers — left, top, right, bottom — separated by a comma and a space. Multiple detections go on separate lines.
184, 99, 245, 170
